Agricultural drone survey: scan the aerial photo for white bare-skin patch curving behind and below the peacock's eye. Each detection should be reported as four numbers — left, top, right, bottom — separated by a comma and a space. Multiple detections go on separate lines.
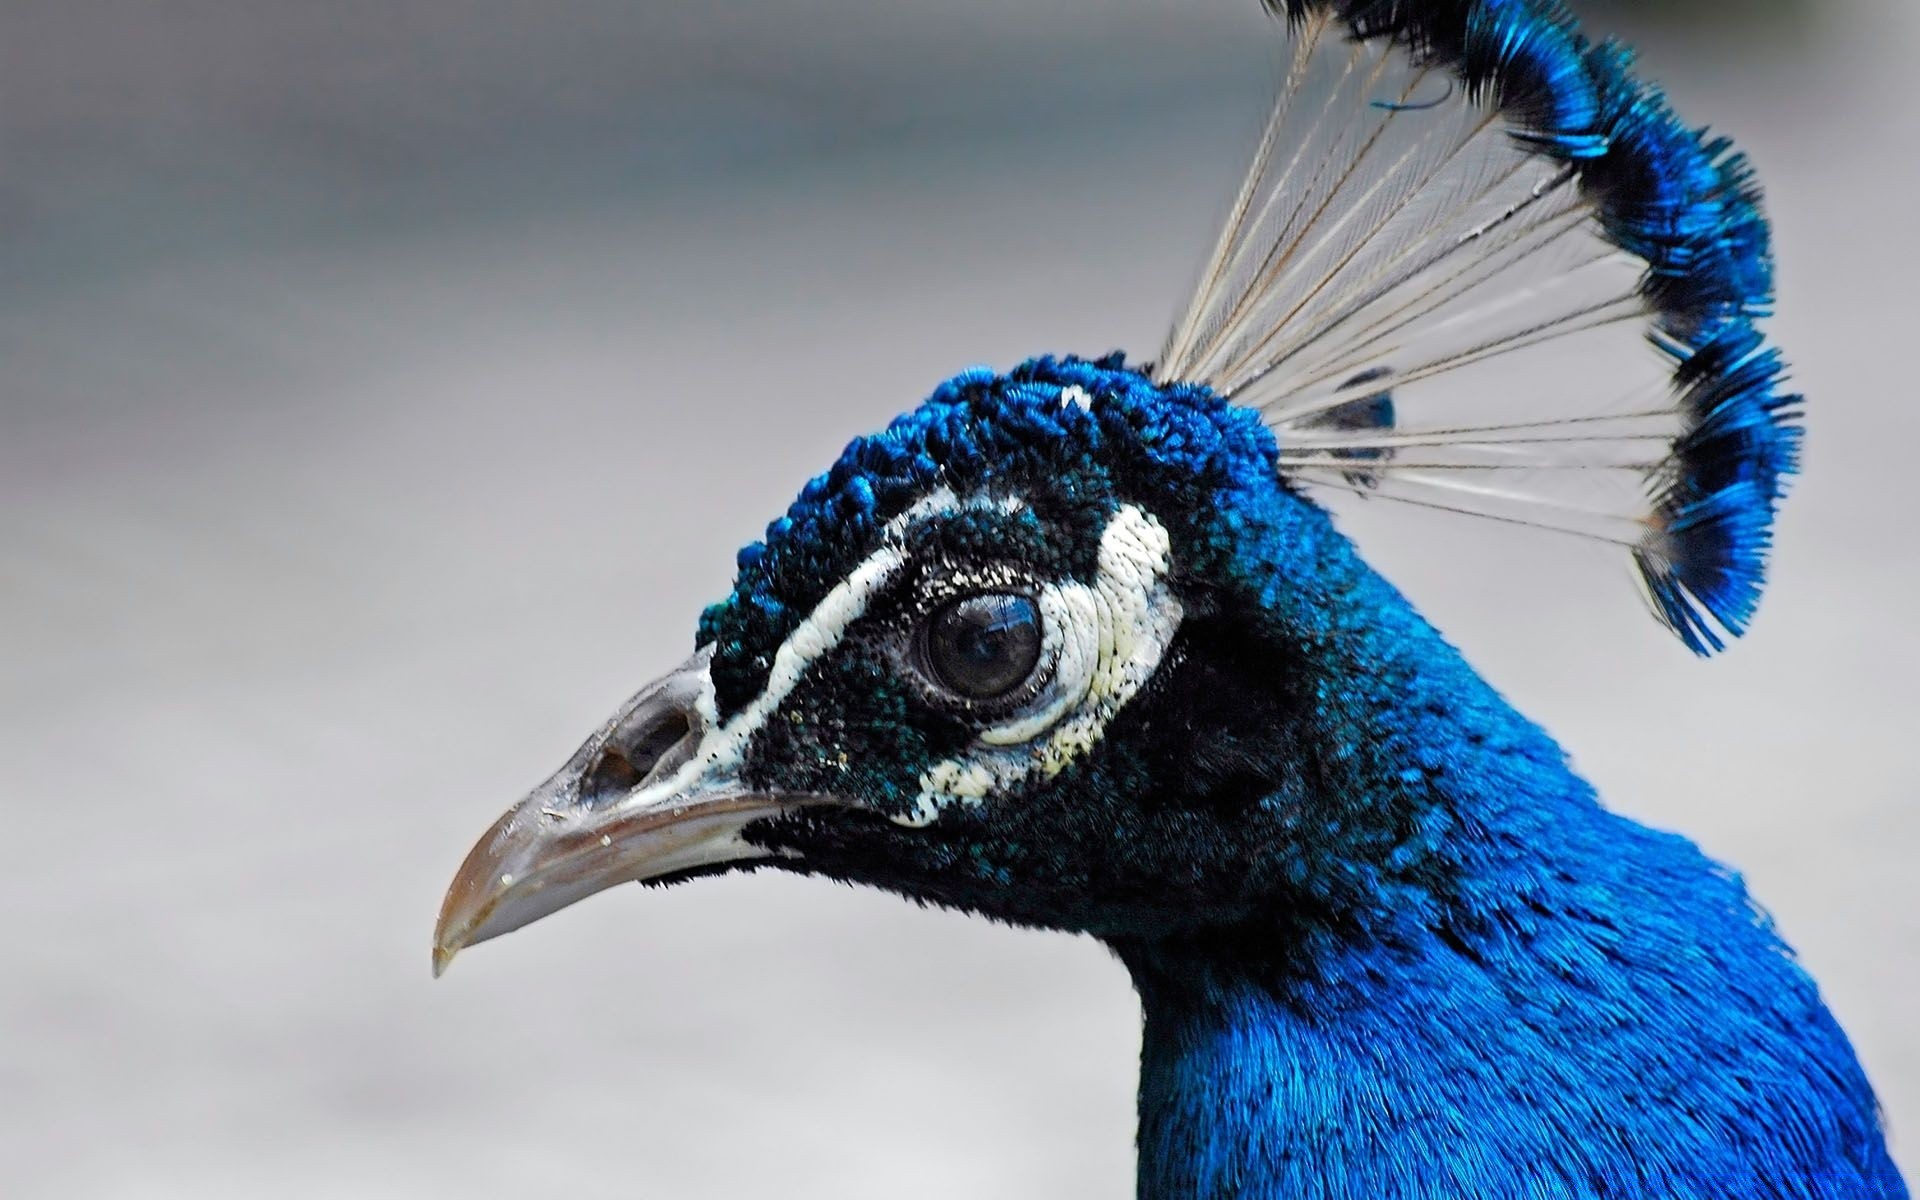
893, 505, 1183, 828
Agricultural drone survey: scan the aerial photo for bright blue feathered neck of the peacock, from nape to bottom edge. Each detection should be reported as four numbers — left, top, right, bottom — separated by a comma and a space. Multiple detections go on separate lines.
1116, 545, 1907, 1200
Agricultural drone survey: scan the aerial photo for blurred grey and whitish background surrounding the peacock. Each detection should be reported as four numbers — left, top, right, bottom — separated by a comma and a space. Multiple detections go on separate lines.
0, 0, 1920, 1200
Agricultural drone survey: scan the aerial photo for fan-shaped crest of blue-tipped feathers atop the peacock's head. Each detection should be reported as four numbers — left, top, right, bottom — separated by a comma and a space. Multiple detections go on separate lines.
1156, 0, 1799, 653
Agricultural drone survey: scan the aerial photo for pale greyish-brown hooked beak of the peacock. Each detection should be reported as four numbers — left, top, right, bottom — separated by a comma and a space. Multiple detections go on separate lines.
434, 649, 808, 977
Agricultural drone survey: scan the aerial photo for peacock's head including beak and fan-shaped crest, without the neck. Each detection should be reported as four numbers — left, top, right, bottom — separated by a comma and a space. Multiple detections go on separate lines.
436, 0, 1799, 964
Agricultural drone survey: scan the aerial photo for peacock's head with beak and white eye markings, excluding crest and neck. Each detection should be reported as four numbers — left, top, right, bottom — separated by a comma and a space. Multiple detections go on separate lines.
436, 357, 1413, 964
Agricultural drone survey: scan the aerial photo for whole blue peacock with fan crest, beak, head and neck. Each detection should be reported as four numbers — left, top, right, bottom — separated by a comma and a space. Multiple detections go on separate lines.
434, 0, 1908, 1200
